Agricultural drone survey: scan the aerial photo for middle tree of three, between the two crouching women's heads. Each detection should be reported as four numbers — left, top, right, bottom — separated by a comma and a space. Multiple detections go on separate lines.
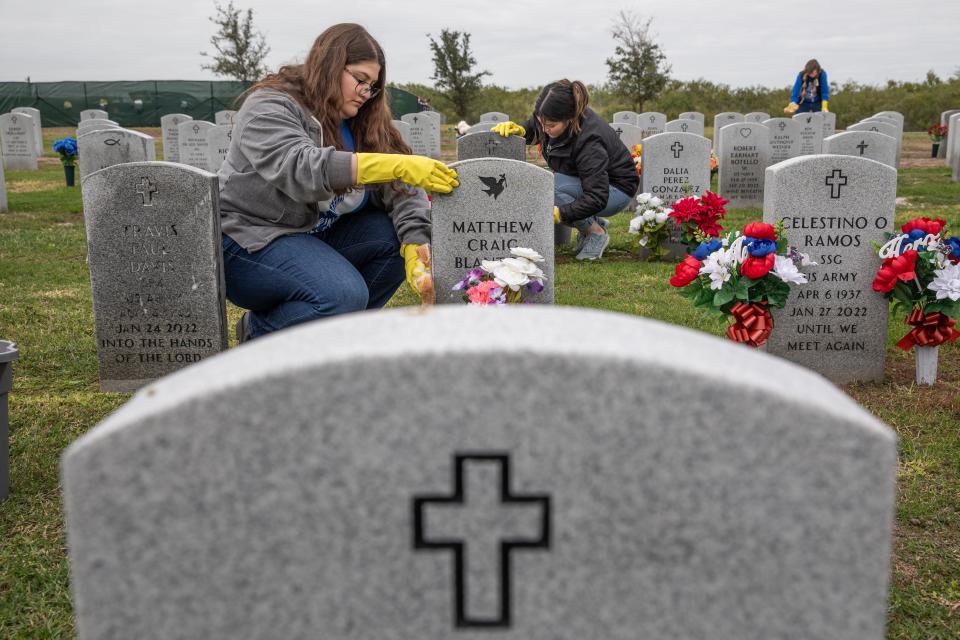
427, 29, 490, 119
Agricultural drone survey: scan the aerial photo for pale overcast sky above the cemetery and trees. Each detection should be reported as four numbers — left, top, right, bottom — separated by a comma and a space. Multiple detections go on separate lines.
0, 0, 960, 88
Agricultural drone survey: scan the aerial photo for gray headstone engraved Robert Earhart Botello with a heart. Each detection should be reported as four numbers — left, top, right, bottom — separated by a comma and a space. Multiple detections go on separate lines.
718, 122, 770, 209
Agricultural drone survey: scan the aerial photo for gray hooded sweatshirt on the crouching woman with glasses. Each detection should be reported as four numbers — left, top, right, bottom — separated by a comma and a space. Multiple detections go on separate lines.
218, 89, 430, 252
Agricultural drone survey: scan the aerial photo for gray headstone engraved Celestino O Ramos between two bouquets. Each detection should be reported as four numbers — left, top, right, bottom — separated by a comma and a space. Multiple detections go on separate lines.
763, 155, 897, 384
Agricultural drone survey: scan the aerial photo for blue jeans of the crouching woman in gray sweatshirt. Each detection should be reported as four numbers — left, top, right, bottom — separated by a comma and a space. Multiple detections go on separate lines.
223, 210, 405, 338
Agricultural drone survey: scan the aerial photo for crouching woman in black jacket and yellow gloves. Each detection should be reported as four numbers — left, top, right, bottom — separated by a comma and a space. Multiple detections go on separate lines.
492, 80, 640, 260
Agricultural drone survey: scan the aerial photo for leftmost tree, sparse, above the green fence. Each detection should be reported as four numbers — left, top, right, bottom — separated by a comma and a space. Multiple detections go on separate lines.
200, 0, 270, 82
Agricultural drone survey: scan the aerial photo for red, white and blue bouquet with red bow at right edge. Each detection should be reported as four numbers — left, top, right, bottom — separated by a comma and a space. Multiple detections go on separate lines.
873, 218, 960, 351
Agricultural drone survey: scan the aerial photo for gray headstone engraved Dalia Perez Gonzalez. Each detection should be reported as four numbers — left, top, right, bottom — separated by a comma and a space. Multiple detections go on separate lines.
640, 132, 710, 207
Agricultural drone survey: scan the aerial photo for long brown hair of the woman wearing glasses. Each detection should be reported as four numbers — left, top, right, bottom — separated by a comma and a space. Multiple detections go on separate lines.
243, 23, 410, 153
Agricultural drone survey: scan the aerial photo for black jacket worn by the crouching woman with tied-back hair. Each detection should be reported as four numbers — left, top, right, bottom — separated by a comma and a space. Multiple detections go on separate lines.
521, 108, 640, 222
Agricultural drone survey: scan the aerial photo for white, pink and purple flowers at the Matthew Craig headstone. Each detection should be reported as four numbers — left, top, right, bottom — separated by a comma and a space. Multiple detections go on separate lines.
453, 247, 546, 305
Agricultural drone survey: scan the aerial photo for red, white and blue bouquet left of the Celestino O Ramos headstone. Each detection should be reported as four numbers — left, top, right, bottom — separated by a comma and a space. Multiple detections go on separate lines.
670, 221, 816, 347
